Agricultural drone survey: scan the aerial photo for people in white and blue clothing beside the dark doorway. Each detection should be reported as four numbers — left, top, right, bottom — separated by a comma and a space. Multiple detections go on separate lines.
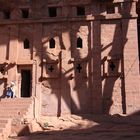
6, 81, 16, 98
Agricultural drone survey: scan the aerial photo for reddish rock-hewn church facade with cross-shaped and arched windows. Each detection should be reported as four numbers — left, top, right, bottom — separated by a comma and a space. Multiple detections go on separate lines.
0, 0, 140, 116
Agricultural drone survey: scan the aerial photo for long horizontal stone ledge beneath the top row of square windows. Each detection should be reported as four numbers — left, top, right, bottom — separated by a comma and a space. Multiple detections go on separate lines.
0, 14, 137, 25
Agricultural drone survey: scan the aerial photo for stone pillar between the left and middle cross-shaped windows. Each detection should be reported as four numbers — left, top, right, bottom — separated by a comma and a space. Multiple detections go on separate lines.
60, 23, 73, 115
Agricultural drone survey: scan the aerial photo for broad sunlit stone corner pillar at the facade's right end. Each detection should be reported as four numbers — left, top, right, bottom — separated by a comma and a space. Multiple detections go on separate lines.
122, 19, 140, 114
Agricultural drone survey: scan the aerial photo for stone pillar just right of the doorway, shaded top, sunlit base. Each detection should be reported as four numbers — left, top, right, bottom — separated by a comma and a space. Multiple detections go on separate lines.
32, 24, 42, 119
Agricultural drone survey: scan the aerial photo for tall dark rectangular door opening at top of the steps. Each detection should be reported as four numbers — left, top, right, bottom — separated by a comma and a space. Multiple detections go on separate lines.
21, 70, 31, 97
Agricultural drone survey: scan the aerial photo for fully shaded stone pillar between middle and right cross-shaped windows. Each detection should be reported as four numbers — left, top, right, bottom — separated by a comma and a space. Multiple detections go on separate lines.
91, 21, 102, 114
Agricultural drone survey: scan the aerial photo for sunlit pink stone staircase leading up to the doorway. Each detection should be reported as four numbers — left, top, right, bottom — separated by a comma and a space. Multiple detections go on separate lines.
0, 98, 34, 139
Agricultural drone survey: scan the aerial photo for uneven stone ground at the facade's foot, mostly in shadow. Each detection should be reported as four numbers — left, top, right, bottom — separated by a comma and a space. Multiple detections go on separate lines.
8, 115, 140, 140
